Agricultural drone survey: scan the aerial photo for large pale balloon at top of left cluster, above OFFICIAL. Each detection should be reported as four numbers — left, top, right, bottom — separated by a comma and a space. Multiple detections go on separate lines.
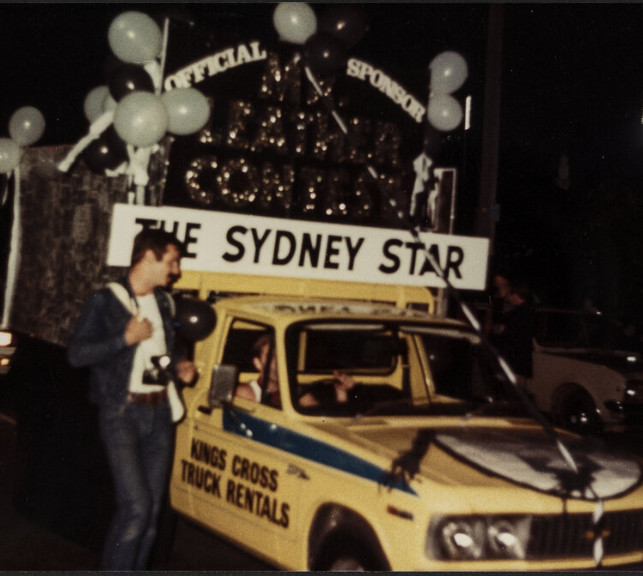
107, 11, 163, 64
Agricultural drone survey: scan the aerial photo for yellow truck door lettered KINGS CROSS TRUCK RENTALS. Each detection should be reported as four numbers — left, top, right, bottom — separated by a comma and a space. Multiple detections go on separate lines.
175, 321, 304, 558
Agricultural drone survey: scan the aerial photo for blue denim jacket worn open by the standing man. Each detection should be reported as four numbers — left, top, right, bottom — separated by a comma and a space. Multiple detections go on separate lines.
67, 279, 176, 405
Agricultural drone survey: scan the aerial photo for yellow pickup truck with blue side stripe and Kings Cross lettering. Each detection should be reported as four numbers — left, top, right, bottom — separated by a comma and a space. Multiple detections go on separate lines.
170, 272, 643, 571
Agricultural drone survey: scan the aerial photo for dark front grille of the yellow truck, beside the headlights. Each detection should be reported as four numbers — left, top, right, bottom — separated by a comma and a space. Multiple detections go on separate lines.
527, 510, 643, 559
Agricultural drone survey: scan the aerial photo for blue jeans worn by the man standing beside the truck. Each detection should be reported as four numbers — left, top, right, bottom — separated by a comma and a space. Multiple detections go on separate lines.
100, 401, 174, 570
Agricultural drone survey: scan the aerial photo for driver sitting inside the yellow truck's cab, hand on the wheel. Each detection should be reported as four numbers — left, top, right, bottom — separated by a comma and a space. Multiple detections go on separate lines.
235, 334, 355, 408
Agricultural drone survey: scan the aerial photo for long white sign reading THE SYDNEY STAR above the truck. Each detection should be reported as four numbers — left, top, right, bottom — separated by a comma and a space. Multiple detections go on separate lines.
107, 204, 489, 290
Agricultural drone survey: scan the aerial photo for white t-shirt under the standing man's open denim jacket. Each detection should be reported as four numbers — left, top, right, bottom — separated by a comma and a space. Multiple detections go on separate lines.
129, 293, 167, 394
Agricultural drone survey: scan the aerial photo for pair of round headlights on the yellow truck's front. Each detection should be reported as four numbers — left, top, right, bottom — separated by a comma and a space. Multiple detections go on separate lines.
426, 516, 530, 560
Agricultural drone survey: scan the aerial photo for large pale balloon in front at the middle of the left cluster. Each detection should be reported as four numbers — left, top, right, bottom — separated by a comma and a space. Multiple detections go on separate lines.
114, 92, 169, 148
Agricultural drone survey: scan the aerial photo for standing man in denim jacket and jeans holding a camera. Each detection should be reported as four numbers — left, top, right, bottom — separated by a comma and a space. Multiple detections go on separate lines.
68, 229, 197, 570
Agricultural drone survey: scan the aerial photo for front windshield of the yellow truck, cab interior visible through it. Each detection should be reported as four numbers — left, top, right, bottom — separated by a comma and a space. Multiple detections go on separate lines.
286, 322, 518, 416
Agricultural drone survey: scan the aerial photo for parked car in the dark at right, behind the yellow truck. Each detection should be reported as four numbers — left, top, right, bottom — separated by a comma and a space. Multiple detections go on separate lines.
527, 307, 643, 434
